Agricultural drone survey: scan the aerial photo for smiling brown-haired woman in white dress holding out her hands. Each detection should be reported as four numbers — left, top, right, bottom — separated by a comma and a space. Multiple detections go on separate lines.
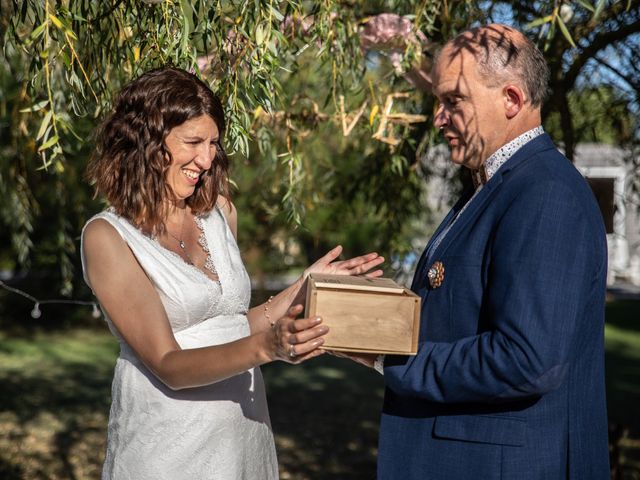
82, 68, 383, 480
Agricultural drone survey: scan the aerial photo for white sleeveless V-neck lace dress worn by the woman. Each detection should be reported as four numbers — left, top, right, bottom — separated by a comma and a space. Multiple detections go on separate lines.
83, 207, 278, 480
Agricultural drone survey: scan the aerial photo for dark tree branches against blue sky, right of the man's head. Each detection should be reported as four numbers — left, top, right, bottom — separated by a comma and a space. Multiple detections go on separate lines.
487, 0, 640, 160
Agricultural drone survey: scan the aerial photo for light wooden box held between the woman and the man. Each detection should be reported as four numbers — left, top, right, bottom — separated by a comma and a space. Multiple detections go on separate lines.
305, 274, 420, 355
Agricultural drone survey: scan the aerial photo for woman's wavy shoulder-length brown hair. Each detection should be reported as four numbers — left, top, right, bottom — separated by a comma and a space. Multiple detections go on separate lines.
87, 67, 229, 235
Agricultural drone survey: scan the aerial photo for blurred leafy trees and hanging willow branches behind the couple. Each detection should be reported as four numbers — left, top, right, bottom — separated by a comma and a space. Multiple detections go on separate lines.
0, 0, 640, 294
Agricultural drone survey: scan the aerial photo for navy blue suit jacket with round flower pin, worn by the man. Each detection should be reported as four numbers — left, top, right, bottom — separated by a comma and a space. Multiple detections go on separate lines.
378, 134, 610, 480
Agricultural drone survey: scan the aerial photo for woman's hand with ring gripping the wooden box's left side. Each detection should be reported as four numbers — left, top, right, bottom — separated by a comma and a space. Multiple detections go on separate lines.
267, 305, 329, 364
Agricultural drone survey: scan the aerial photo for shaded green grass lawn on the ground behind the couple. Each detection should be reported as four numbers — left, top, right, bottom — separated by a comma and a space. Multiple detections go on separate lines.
0, 301, 640, 480
